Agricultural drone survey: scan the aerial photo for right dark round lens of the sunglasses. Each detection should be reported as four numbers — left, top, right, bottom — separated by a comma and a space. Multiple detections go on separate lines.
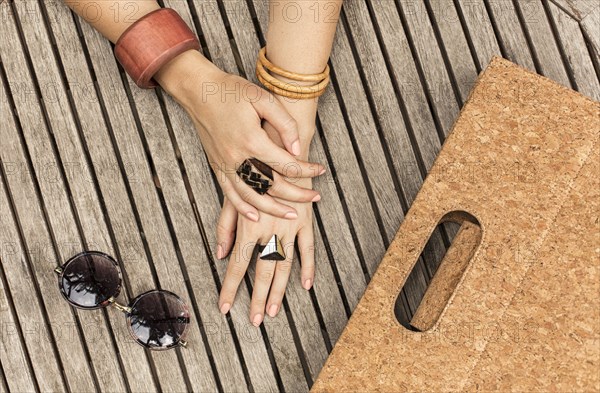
128, 291, 190, 349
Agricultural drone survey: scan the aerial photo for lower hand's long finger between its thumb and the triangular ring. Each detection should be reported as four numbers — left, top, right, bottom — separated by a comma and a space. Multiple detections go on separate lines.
219, 228, 258, 314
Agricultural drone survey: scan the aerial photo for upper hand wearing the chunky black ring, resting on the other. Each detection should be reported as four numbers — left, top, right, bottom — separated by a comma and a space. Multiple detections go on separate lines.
155, 51, 325, 221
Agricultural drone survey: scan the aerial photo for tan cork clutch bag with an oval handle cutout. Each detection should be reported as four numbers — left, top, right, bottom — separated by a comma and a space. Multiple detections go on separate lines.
312, 57, 600, 392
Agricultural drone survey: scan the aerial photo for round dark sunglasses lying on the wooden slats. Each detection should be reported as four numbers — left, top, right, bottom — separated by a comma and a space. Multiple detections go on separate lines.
54, 251, 190, 351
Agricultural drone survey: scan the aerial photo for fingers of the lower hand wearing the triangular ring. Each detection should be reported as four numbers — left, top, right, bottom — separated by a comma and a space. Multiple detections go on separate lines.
217, 179, 315, 326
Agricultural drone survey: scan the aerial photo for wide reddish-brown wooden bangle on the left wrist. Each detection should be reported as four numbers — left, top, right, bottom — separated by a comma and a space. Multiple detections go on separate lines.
115, 8, 200, 89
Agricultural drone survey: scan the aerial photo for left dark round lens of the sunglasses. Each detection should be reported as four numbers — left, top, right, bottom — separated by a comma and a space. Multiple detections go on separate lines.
60, 253, 121, 308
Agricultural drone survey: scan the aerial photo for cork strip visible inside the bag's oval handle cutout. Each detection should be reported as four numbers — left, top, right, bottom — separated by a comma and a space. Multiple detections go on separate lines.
398, 211, 482, 332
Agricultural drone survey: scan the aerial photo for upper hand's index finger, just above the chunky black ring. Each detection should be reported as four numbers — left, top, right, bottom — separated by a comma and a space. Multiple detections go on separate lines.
256, 139, 325, 178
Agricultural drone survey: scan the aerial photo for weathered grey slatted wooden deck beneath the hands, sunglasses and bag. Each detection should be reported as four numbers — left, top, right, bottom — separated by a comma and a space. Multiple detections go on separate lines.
0, 0, 600, 392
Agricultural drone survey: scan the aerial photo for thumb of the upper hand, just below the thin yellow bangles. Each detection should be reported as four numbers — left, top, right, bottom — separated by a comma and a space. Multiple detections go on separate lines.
252, 90, 301, 156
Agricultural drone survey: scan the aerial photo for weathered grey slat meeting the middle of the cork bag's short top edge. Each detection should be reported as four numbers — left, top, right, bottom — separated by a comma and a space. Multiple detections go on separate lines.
515, 0, 572, 88
